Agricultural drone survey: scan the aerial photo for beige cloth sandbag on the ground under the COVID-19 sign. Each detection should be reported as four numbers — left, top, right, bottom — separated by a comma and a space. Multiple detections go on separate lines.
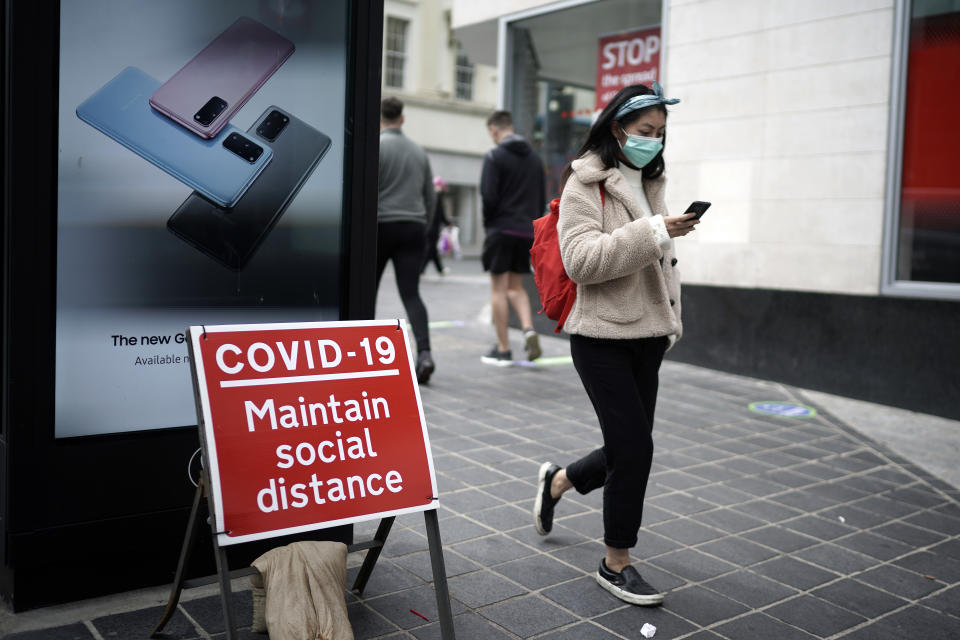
252, 541, 353, 640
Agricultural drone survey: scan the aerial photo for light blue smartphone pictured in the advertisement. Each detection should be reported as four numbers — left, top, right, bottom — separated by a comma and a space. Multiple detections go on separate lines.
77, 67, 273, 207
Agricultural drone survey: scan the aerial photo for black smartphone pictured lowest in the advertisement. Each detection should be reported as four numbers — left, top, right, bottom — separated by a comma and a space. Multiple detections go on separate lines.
167, 106, 330, 271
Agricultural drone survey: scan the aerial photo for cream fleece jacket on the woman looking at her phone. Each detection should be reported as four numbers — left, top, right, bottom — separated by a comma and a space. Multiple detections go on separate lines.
557, 153, 683, 342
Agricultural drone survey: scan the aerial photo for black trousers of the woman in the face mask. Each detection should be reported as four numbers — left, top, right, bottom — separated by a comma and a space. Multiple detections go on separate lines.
567, 335, 668, 549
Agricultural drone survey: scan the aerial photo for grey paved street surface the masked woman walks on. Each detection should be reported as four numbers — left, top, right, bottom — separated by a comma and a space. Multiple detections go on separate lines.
0, 259, 960, 640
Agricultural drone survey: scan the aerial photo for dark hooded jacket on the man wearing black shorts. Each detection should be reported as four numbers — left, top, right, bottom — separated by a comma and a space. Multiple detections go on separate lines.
480, 134, 547, 238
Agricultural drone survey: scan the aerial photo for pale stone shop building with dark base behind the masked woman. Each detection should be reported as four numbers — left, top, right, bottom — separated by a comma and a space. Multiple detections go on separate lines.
453, 0, 960, 418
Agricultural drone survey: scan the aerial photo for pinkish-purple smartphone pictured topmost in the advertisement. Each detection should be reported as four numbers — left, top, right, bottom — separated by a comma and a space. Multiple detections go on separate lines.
150, 16, 295, 139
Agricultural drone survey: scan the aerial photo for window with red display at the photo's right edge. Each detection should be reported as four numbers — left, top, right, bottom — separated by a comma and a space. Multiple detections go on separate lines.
894, 0, 960, 284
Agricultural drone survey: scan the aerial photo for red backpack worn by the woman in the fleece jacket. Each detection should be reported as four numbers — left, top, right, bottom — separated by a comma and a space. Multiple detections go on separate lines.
530, 183, 606, 333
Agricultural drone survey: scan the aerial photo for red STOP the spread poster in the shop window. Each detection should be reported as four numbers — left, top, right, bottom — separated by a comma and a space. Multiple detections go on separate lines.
595, 25, 660, 111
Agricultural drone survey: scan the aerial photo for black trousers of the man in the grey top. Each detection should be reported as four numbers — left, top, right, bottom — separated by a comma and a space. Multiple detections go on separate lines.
377, 221, 430, 353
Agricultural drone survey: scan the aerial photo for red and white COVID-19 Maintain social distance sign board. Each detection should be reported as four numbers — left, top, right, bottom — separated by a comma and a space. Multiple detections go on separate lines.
190, 320, 437, 545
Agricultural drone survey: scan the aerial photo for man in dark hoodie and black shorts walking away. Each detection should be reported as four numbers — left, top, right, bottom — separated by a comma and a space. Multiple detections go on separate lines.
480, 111, 546, 366
